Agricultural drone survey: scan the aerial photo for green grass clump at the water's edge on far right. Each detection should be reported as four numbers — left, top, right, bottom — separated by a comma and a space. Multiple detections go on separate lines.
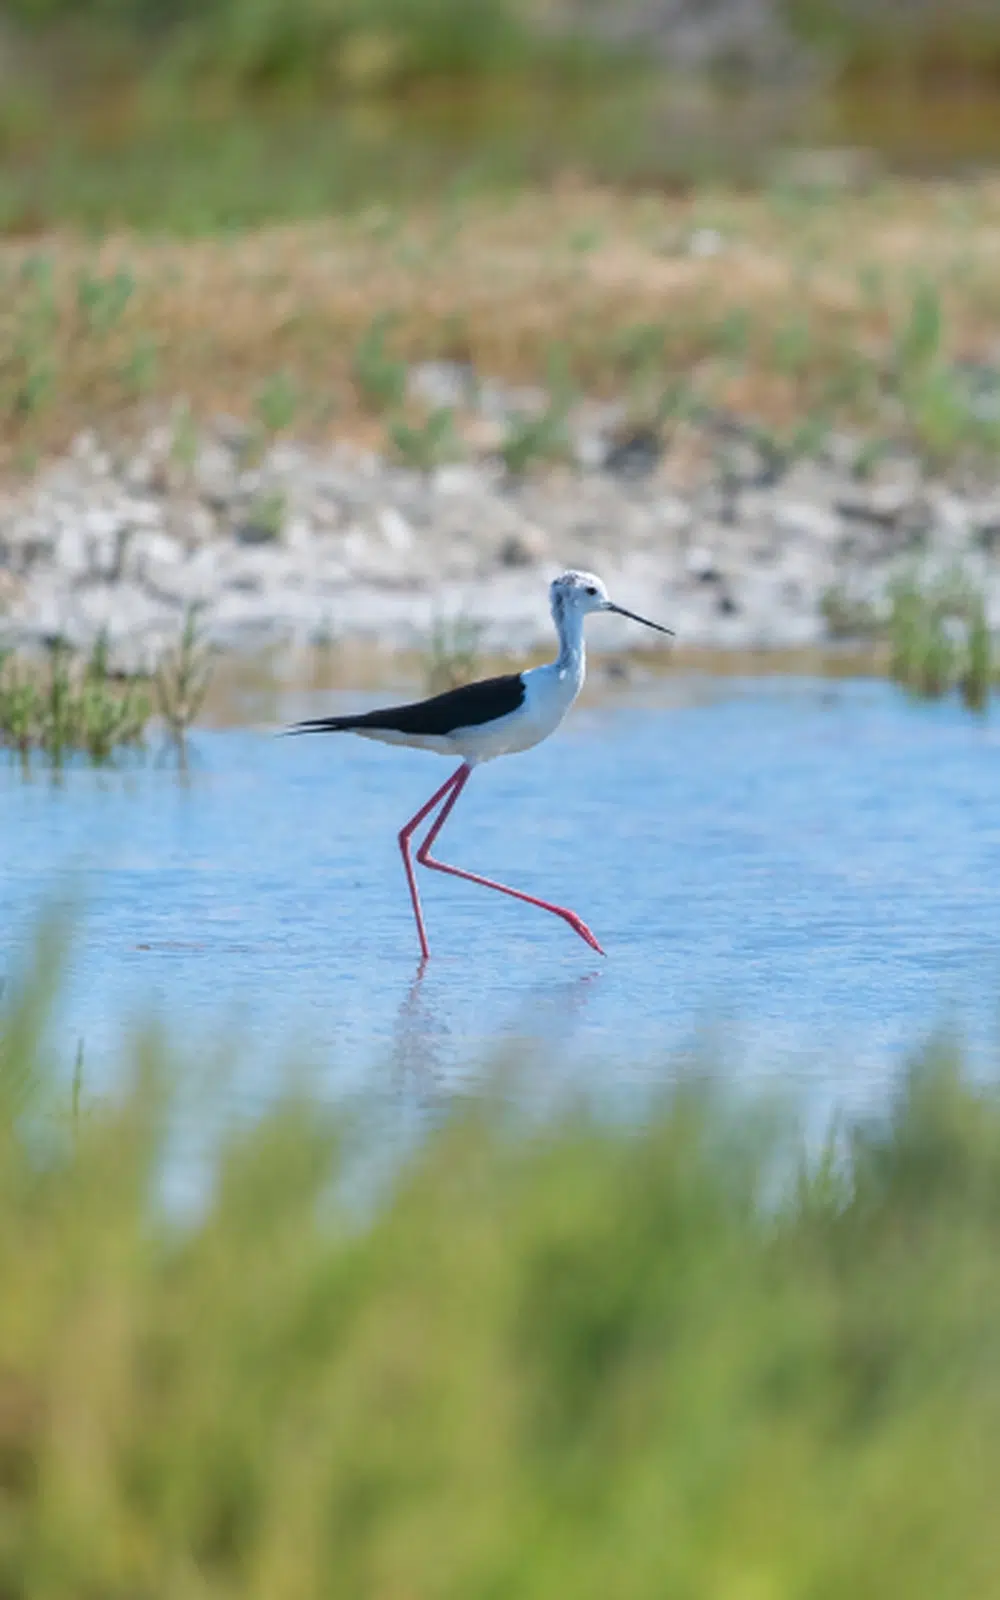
888, 573, 997, 710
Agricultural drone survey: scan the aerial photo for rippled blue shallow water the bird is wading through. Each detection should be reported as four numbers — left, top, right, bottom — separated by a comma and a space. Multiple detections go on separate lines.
0, 680, 1000, 1139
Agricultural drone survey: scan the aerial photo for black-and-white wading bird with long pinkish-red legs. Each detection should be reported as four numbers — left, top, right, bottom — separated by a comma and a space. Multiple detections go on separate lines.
288, 571, 672, 960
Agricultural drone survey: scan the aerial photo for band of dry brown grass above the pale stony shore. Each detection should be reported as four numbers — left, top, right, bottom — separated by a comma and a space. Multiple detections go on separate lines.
0, 181, 1000, 469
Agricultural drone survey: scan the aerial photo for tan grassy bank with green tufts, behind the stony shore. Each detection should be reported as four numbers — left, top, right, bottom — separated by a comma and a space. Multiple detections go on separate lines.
0, 179, 1000, 475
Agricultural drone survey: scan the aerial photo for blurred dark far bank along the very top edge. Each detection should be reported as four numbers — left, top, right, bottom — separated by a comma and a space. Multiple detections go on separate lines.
3, 0, 1000, 96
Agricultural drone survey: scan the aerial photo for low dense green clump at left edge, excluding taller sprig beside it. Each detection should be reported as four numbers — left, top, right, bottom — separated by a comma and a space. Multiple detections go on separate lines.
0, 638, 150, 766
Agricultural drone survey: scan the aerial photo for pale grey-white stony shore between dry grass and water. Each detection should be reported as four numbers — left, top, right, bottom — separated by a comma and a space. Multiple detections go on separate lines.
0, 370, 1000, 670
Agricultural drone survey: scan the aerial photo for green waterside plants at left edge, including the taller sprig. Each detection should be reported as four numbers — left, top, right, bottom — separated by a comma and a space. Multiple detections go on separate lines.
0, 611, 210, 766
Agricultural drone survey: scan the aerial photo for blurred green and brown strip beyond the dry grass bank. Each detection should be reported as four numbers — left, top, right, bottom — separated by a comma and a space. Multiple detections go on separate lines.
0, 0, 1000, 232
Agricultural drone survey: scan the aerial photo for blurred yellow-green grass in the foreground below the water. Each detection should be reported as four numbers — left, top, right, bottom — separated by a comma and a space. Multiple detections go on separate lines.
0, 938, 1000, 1600
